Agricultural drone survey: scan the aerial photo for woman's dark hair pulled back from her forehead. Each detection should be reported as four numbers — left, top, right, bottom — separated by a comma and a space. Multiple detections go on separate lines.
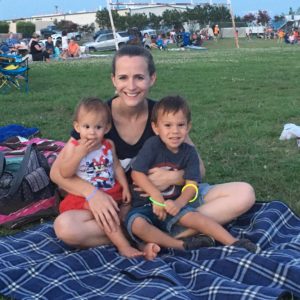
112, 45, 155, 76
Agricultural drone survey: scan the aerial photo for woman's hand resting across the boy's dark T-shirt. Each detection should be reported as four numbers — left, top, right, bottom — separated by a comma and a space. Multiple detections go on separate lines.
148, 168, 183, 191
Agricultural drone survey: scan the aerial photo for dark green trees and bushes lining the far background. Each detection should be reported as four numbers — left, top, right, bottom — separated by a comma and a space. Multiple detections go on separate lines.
0, 4, 300, 36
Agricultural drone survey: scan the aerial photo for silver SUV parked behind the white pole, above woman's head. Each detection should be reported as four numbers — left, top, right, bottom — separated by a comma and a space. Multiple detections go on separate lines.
83, 31, 129, 52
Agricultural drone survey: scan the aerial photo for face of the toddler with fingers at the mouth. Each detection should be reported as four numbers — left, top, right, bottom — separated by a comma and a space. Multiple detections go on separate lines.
74, 110, 110, 143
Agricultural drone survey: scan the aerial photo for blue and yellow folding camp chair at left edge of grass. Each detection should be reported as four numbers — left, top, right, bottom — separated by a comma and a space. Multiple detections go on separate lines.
0, 54, 29, 93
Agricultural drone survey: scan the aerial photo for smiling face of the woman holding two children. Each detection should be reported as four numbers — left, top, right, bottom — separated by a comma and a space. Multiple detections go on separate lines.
112, 56, 156, 107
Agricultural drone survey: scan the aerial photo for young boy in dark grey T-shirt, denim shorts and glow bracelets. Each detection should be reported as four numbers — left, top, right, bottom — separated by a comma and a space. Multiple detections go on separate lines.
126, 96, 256, 252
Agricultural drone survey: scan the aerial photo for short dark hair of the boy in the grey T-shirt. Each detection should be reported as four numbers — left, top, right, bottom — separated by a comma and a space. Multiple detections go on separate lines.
151, 96, 191, 123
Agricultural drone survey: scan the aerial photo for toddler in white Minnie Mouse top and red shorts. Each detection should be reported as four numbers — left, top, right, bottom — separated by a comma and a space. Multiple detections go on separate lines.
59, 98, 143, 257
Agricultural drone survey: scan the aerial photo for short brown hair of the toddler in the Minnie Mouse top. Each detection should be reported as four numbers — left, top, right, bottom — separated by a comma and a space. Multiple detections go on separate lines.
73, 97, 111, 124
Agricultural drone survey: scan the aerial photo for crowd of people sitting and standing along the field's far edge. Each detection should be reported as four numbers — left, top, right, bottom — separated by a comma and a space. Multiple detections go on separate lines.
0, 24, 300, 62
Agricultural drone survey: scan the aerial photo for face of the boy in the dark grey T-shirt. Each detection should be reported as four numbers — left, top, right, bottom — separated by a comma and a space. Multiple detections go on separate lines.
152, 110, 191, 152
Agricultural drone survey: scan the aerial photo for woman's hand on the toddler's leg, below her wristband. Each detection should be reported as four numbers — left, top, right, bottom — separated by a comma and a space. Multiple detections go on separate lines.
89, 190, 120, 233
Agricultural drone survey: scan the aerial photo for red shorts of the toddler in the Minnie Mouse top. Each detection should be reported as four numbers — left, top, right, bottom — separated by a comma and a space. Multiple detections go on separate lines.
59, 182, 122, 213
